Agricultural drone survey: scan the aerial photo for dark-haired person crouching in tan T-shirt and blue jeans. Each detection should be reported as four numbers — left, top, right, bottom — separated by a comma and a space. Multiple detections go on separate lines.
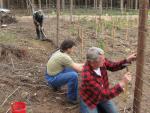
45, 39, 83, 104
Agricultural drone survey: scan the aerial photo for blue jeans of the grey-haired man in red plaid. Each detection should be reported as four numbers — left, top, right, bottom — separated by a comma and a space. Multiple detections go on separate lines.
80, 99, 118, 113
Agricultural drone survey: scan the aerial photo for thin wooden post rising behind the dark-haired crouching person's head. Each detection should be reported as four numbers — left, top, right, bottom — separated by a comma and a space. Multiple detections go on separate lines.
56, 0, 60, 47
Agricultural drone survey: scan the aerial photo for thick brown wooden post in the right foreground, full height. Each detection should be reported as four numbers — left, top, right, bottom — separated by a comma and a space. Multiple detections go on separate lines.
133, 0, 149, 113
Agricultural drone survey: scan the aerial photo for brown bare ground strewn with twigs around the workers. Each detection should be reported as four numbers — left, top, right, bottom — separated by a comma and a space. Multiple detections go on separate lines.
0, 17, 150, 113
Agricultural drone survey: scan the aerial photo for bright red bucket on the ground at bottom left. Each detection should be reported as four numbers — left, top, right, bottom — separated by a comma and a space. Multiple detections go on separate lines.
11, 102, 26, 113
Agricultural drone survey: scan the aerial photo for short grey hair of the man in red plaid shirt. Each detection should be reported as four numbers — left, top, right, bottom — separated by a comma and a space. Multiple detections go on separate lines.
86, 47, 104, 61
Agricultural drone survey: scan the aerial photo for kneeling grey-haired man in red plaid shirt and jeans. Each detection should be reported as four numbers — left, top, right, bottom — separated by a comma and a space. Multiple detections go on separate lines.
80, 47, 136, 113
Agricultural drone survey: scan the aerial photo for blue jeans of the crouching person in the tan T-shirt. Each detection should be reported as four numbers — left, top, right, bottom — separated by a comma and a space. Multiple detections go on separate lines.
45, 68, 78, 101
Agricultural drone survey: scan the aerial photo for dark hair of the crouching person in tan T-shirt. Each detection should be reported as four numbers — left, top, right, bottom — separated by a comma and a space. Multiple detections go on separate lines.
60, 39, 75, 52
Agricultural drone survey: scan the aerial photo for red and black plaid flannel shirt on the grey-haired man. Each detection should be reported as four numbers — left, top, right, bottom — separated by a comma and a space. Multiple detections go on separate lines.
80, 59, 128, 109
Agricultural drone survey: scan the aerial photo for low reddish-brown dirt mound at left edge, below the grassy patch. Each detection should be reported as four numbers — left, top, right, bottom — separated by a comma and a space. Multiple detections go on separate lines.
0, 44, 27, 60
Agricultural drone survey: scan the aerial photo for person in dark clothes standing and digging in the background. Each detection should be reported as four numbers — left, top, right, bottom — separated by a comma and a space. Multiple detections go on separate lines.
33, 10, 46, 40
